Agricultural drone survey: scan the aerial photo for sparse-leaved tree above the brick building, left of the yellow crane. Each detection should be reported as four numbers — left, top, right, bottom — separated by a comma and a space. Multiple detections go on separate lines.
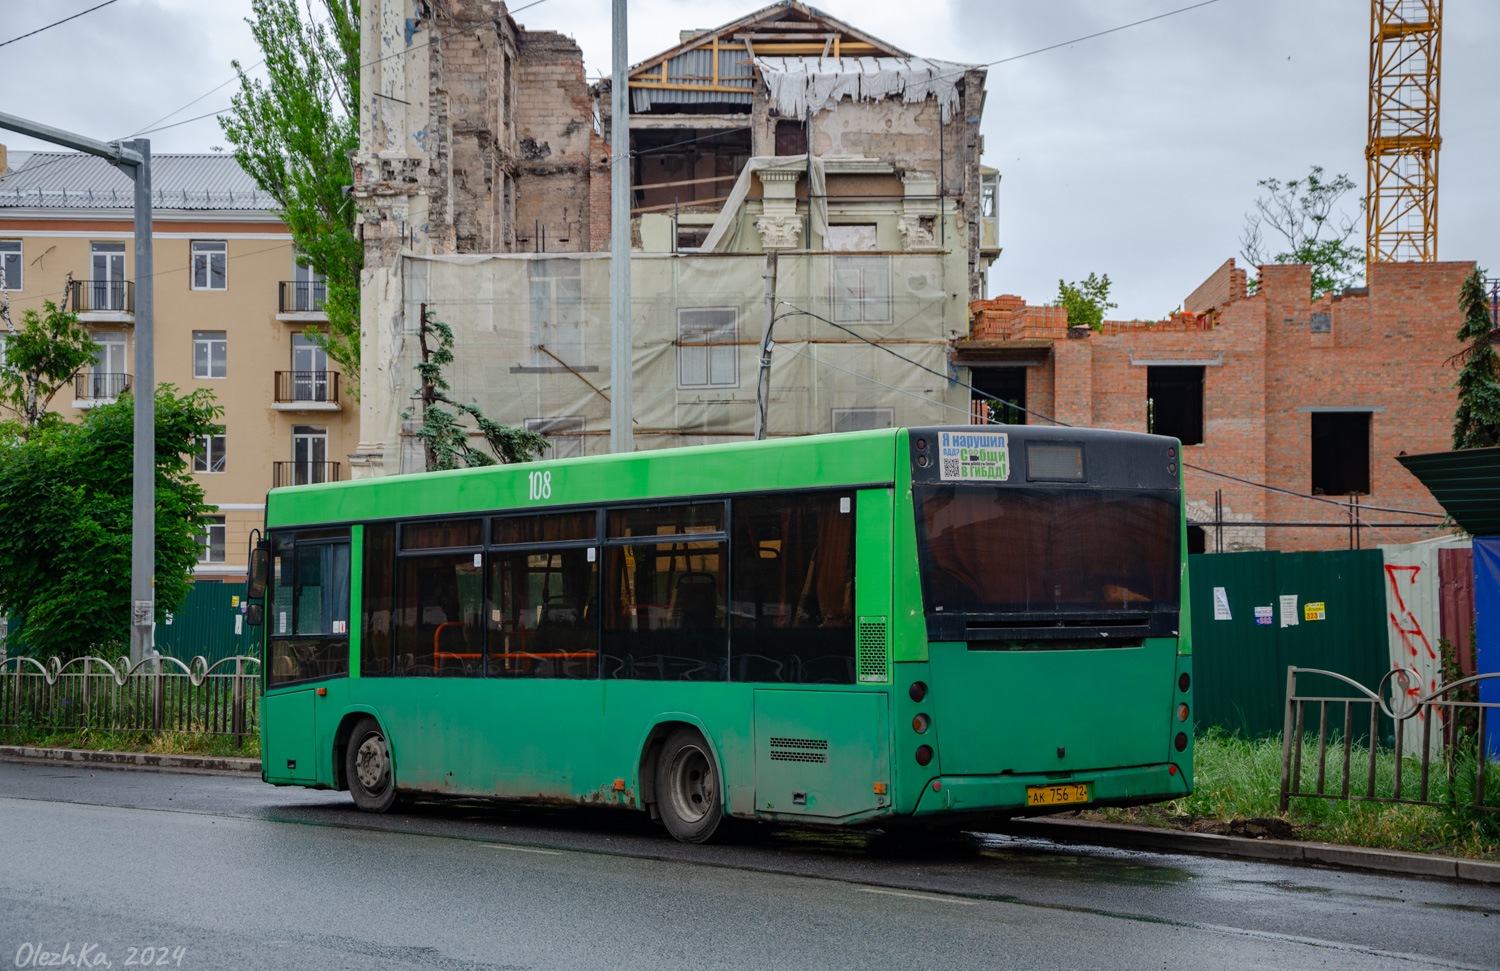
1239, 165, 1365, 300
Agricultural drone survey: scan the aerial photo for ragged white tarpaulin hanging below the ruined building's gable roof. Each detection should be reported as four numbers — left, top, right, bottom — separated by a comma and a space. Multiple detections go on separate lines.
755, 57, 977, 123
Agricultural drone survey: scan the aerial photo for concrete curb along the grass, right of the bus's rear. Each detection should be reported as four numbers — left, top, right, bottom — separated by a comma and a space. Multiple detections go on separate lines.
998, 818, 1500, 884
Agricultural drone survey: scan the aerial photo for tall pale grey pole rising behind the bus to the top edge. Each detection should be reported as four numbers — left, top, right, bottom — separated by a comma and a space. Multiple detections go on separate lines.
609, 0, 636, 452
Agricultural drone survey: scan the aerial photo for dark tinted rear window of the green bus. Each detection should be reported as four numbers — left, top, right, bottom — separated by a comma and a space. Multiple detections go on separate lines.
917, 485, 1181, 615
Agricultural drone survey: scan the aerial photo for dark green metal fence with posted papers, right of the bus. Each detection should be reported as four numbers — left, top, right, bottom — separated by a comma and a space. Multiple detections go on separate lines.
1188, 549, 1391, 735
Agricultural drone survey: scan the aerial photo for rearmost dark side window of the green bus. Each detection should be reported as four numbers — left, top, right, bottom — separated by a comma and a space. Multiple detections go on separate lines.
731, 492, 855, 684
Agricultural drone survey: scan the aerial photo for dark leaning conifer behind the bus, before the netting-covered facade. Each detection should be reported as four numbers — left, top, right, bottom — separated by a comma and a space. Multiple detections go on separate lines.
401, 311, 548, 471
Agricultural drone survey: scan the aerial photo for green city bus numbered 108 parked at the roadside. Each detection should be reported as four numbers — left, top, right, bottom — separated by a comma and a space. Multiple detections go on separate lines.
251, 425, 1193, 842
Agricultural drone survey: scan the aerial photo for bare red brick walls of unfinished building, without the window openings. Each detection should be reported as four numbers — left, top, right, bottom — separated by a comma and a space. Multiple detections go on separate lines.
960, 261, 1473, 551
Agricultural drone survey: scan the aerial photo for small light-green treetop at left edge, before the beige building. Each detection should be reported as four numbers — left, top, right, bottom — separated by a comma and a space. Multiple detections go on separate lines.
0, 300, 99, 438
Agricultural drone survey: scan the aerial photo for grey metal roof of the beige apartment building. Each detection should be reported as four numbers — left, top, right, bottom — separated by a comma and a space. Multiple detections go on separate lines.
0, 152, 276, 212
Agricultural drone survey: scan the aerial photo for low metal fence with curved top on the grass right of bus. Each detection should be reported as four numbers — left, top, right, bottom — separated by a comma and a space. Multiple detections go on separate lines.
1280, 666, 1500, 812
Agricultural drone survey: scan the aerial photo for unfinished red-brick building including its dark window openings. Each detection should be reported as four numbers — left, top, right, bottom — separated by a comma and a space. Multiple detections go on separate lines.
954, 260, 1473, 552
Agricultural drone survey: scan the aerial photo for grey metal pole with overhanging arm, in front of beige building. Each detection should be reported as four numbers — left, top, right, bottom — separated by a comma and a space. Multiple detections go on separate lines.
0, 113, 156, 665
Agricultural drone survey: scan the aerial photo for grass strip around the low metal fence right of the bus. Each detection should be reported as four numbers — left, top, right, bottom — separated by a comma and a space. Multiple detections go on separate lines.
1080, 728, 1500, 860
